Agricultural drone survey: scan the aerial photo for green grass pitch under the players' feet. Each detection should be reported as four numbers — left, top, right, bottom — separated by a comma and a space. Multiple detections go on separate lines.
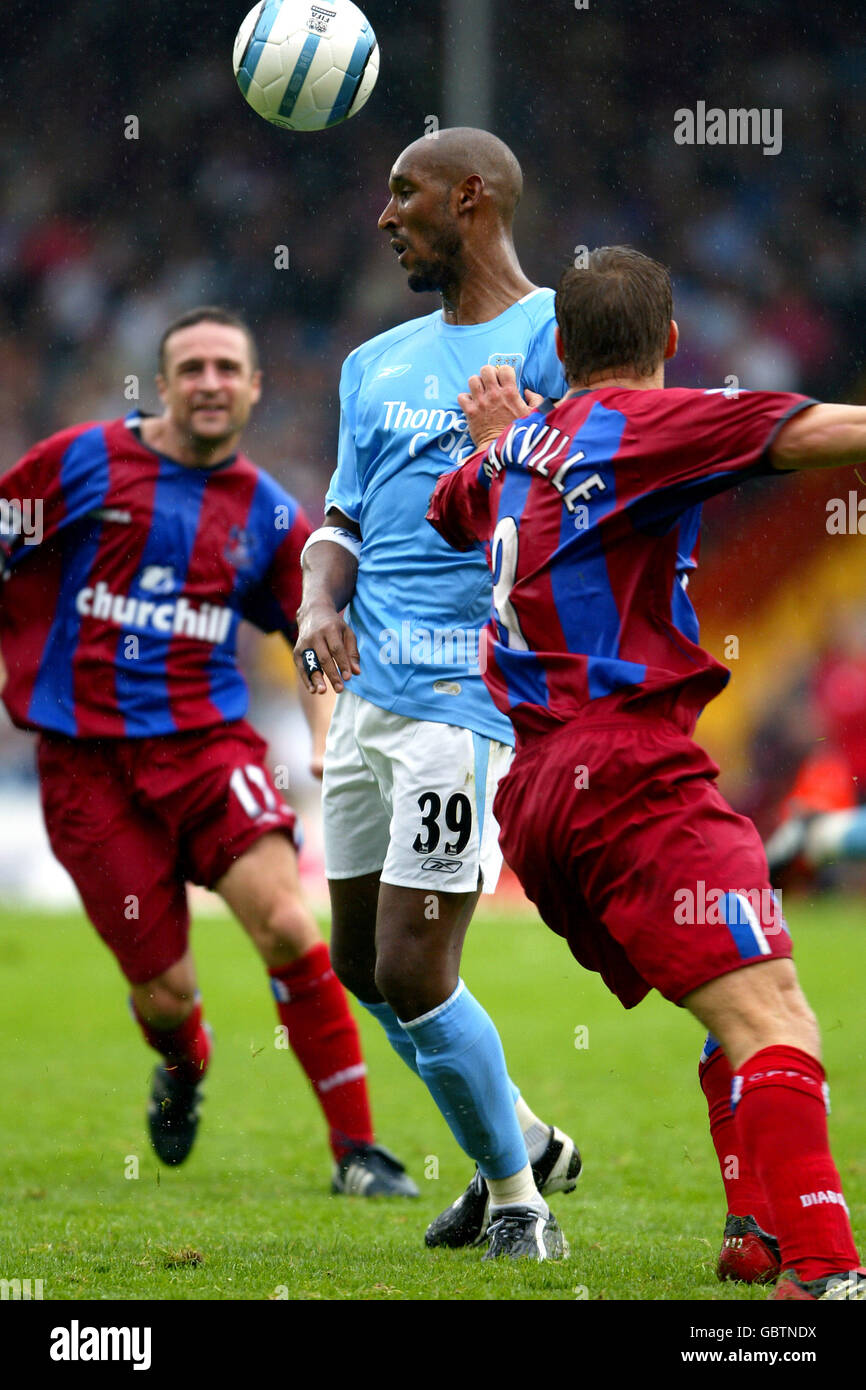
0, 899, 866, 1300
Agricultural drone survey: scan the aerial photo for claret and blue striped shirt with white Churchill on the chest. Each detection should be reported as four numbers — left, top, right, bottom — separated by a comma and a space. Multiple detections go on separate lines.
0, 411, 310, 738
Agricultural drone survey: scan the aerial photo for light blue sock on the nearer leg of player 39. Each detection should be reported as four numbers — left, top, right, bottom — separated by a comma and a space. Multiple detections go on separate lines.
402, 980, 527, 1179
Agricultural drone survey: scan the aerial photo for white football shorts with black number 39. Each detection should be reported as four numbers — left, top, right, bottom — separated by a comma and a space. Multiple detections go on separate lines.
322, 691, 512, 892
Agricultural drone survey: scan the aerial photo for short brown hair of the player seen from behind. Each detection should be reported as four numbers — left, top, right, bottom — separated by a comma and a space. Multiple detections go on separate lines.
556, 246, 673, 385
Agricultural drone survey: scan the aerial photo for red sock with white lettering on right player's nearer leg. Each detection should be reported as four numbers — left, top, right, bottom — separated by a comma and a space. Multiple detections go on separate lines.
734, 1047, 860, 1280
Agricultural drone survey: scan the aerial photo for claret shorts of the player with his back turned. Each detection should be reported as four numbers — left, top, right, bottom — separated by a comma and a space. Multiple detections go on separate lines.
495, 713, 791, 1008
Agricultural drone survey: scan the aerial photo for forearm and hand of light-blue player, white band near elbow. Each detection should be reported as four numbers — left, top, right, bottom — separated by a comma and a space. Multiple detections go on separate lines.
295, 507, 361, 695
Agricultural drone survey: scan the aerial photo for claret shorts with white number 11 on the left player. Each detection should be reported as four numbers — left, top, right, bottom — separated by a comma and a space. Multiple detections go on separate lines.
38, 720, 300, 984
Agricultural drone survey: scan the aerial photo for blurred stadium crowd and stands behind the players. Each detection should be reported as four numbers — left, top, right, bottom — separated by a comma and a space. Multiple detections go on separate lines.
0, 0, 866, 899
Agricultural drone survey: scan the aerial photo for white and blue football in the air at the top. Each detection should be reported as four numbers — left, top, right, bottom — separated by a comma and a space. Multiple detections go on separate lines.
232, 0, 379, 131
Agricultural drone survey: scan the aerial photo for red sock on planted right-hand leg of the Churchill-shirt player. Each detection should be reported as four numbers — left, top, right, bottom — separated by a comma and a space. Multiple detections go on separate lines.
268, 941, 373, 1159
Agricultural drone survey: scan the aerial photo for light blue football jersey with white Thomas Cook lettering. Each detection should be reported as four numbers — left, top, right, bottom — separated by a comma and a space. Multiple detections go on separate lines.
325, 289, 567, 744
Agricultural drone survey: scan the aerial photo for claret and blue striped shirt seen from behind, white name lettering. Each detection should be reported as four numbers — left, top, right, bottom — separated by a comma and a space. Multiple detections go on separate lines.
428, 386, 815, 738
